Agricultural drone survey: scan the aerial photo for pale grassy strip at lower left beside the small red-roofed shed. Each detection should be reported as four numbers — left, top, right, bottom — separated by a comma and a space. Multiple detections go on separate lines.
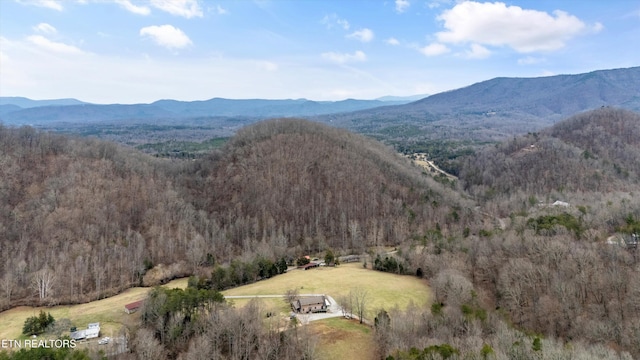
0, 279, 187, 340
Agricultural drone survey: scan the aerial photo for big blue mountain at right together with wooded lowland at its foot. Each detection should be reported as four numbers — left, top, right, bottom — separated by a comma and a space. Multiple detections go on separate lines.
317, 67, 640, 140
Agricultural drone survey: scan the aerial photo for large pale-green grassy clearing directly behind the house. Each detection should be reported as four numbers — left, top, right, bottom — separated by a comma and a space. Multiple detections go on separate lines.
222, 263, 431, 319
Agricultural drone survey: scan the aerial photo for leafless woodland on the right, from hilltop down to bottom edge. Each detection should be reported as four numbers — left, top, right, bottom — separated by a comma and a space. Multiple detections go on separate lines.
364, 108, 640, 359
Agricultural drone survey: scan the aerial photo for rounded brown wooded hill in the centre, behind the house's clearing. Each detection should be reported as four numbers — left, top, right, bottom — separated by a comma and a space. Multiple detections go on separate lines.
185, 119, 470, 250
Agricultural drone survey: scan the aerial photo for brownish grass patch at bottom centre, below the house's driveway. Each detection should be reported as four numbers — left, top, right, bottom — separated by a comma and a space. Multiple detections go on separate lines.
308, 318, 375, 360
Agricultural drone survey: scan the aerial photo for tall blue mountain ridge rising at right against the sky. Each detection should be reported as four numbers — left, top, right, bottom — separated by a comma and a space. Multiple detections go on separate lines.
405, 67, 640, 117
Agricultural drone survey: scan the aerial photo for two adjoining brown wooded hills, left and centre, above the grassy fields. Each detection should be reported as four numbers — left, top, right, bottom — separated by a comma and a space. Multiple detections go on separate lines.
0, 120, 473, 308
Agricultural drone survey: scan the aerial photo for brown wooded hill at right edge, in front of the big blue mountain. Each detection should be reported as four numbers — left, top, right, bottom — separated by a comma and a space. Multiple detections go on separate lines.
460, 108, 640, 198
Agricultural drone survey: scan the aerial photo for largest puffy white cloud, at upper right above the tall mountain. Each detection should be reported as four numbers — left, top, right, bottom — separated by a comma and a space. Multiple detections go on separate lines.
436, 1, 586, 53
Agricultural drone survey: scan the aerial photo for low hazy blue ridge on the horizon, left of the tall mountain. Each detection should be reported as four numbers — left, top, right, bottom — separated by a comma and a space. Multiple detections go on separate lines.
0, 97, 411, 125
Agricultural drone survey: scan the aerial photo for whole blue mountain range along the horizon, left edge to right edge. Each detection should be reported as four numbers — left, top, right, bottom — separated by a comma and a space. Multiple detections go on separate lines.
0, 67, 640, 141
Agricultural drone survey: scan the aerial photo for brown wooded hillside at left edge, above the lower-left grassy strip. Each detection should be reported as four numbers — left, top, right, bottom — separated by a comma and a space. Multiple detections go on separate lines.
0, 127, 206, 308
